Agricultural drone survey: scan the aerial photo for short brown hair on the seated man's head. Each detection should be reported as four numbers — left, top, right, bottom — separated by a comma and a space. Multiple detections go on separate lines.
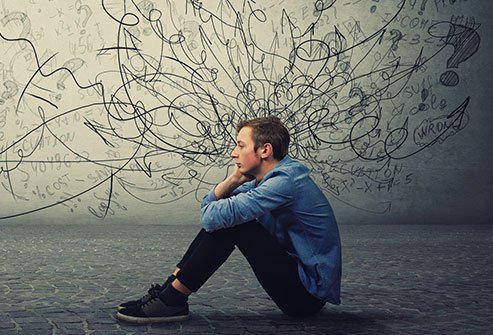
236, 116, 289, 160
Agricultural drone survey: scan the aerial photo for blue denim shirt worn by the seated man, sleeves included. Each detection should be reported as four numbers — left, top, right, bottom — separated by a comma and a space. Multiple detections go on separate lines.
201, 156, 341, 304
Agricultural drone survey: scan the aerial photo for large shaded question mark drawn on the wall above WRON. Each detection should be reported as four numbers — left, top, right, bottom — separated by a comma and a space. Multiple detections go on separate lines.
428, 22, 481, 86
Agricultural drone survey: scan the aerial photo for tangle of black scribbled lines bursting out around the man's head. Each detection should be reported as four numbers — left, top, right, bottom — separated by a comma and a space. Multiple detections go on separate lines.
0, 0, 479, 217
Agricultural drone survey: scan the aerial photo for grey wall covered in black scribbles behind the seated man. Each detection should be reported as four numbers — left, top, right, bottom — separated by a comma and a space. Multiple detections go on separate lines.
0, 0, 493, 224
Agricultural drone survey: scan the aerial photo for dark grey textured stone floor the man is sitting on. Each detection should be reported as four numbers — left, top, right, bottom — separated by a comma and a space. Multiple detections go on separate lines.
0, 224, 493, 335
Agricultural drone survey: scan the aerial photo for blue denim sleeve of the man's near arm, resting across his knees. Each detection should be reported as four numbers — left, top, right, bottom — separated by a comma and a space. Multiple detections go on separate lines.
201, 172, 295, 232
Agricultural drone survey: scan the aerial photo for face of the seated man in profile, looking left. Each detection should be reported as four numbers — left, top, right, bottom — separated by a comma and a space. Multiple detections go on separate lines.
231, 127, 262, 177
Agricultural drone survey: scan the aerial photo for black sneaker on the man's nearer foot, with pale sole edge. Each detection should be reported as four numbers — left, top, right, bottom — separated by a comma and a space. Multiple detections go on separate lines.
116, 291, 190, 324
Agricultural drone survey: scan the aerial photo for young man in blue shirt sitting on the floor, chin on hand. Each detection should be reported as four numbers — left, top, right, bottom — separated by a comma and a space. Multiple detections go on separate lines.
117, 117, 341, 323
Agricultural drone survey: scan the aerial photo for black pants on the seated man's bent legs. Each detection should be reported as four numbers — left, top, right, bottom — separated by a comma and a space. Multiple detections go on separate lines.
177, 221, 325, 316
